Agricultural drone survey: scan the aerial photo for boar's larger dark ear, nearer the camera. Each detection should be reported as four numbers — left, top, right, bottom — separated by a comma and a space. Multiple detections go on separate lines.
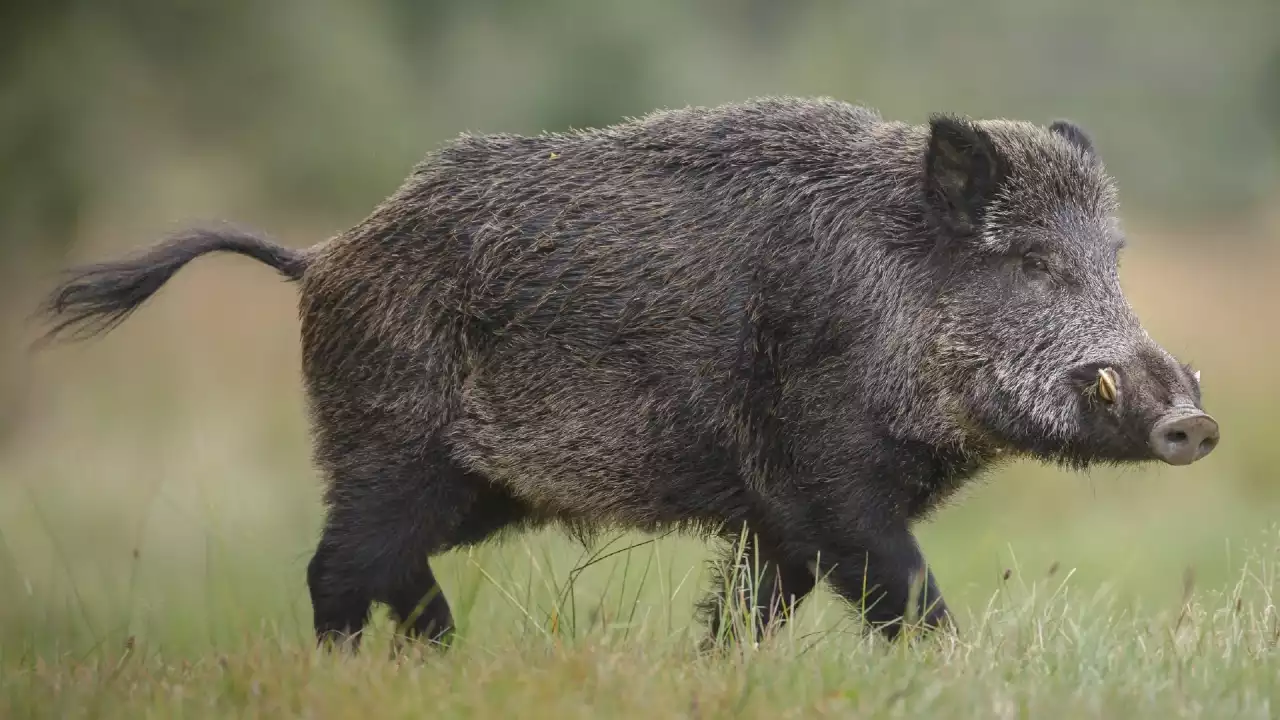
924, 115, 1005, 233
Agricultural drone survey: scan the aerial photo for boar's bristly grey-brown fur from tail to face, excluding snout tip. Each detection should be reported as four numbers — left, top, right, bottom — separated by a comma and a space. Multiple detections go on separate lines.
37, 99, 1199, 650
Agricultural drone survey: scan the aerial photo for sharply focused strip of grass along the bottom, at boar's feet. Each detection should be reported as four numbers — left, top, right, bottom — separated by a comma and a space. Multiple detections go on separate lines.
3, 535, 1280, 717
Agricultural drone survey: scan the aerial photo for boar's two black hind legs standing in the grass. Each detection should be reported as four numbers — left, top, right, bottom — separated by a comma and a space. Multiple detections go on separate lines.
307, 447, 525, 647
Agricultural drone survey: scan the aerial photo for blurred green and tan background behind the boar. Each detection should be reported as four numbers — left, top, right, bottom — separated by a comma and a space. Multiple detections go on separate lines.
0, 0, 1280, 652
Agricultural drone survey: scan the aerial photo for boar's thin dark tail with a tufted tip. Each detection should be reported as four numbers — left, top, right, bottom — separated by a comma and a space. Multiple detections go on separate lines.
40, 222, 308, 340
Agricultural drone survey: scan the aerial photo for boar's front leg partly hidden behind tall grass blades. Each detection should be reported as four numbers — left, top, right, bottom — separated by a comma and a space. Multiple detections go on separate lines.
701, 532, 815, 647
